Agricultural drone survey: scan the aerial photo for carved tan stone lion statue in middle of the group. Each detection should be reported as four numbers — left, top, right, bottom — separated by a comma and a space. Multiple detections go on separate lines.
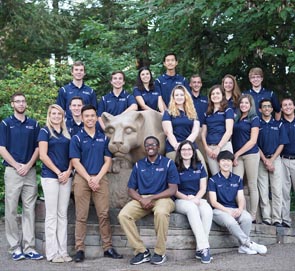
102, 110, 165, 172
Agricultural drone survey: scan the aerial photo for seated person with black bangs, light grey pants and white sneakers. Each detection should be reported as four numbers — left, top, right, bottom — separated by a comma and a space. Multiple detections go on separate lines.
208, 151, 267, 254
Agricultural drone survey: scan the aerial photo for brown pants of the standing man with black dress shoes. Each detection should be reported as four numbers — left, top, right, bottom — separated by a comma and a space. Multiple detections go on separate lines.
73, 173, 112, 251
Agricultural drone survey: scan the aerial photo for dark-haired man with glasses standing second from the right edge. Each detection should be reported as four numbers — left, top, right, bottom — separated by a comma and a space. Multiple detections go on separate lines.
257, 99, 289, 227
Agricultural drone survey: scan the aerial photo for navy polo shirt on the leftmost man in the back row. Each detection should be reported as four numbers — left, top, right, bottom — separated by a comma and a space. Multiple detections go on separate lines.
56, 82, 97, 118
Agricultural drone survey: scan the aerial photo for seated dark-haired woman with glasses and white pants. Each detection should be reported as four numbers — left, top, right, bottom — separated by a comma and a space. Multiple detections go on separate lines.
175, 140, 213, 263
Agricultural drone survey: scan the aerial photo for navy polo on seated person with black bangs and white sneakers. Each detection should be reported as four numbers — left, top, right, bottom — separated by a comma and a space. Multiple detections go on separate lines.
208, 172, 243, 208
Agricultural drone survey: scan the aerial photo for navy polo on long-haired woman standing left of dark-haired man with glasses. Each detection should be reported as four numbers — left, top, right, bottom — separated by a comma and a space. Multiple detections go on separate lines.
232, 116, 260, 155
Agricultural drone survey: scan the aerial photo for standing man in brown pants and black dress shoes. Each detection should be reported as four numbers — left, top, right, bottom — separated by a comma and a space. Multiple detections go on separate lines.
70, 105, 122, 262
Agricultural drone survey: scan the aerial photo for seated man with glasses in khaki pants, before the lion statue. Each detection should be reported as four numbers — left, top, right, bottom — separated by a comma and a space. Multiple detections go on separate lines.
118, 136, 179, 265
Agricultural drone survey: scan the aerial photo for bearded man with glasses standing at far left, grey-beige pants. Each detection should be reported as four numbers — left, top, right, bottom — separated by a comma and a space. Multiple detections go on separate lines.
0, 93, 43, 261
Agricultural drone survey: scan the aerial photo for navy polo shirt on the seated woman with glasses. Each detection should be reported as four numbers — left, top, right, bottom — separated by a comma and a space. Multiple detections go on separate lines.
178, 162, 207, 196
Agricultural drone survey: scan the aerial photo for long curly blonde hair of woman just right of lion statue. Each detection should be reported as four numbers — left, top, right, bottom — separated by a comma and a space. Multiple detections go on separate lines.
168, 85, 198, 120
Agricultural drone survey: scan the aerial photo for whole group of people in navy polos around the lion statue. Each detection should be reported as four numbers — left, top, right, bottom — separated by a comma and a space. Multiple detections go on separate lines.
0, 53, 295, 265
